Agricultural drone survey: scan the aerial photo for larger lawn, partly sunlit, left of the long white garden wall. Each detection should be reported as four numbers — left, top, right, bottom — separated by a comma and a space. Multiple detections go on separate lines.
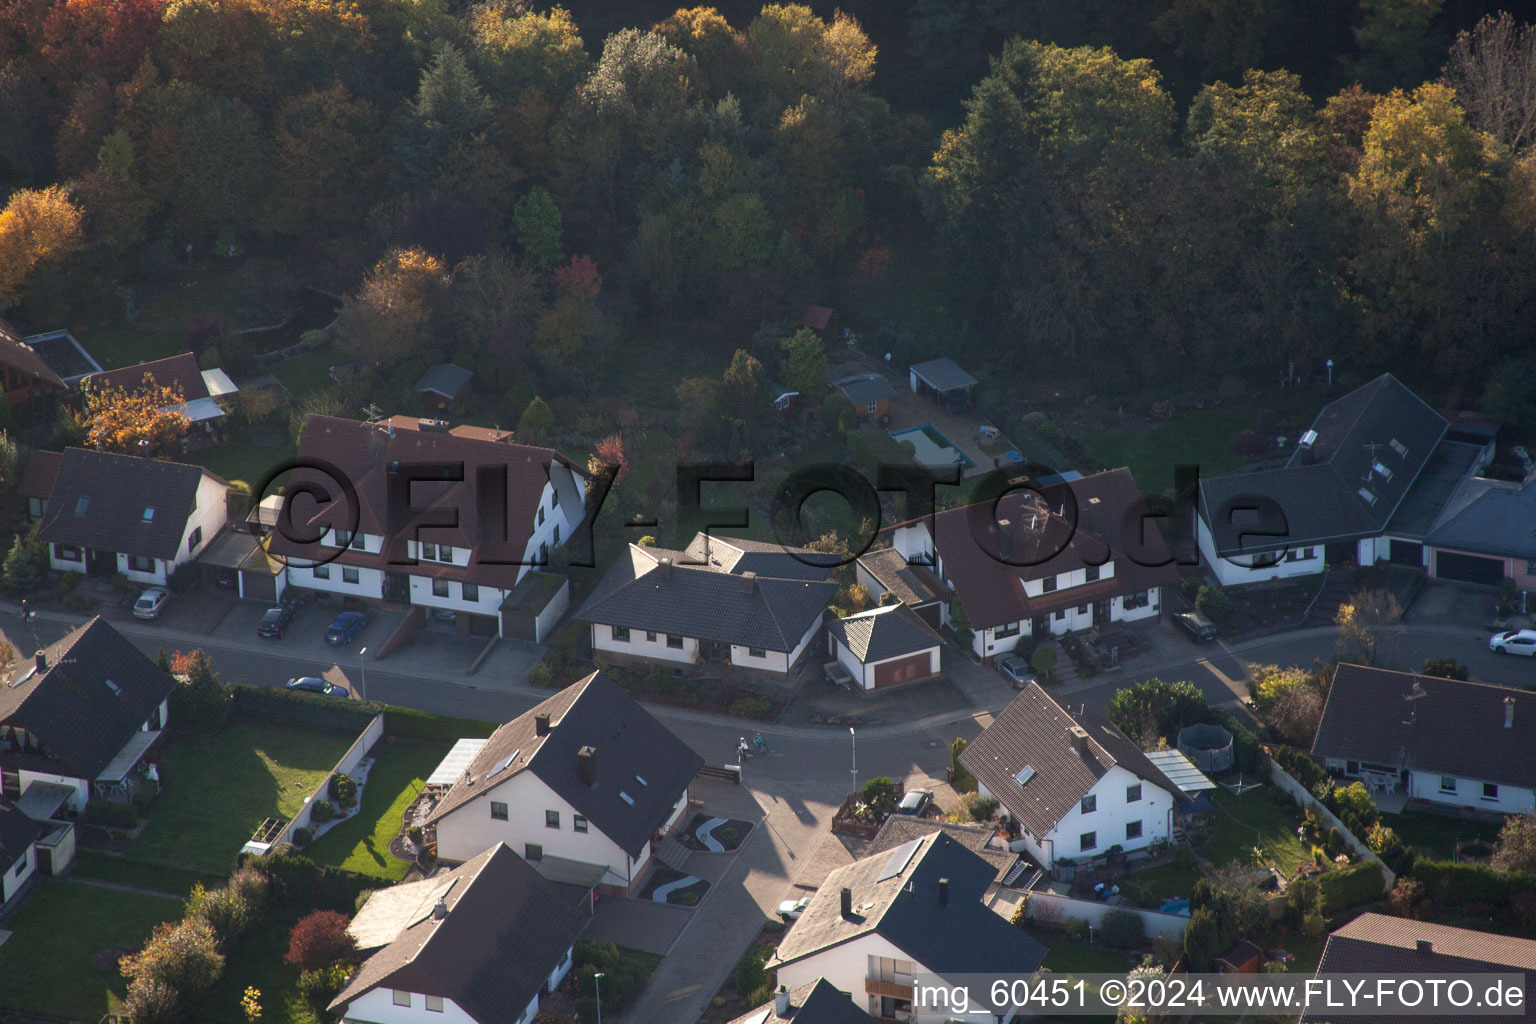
129, 720, 356, 874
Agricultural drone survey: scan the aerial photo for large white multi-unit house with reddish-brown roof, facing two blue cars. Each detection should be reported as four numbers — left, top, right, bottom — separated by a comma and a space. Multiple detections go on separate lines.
267, 416, 587, 640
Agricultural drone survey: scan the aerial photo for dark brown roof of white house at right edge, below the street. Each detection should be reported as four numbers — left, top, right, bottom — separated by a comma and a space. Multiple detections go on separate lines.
1312, 665, 1536, 788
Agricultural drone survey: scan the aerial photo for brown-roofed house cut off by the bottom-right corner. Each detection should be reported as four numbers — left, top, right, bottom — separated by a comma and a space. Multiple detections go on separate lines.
1301, 913, 1536, 1024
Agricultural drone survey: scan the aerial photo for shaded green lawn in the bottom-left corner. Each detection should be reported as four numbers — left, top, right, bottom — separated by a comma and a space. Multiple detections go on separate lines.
0, 881, 183, 1021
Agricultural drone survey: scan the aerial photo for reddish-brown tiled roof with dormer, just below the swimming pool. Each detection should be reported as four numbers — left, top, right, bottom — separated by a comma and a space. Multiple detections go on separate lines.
890, 470, 1178, 629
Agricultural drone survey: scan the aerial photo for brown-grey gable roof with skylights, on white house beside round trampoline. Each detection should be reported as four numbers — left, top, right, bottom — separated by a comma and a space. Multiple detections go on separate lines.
960, 683, 1183, 837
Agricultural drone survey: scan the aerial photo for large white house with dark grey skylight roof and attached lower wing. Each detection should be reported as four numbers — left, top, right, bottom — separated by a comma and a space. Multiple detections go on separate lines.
1195, 373, 1505, 585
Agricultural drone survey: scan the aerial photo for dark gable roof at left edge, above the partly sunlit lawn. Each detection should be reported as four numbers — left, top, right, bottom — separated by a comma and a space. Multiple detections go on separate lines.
0, 617, 175, 778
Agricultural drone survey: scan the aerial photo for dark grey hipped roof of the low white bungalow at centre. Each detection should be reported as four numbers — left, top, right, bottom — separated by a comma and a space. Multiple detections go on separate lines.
576, 543, 837, 652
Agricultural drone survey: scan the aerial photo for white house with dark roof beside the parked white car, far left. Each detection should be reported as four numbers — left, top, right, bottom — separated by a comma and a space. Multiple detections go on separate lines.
37, 448, 229, 586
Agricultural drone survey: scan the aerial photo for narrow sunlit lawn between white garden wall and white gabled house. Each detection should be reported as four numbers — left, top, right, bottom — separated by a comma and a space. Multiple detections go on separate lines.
306, 740, 452, 881
